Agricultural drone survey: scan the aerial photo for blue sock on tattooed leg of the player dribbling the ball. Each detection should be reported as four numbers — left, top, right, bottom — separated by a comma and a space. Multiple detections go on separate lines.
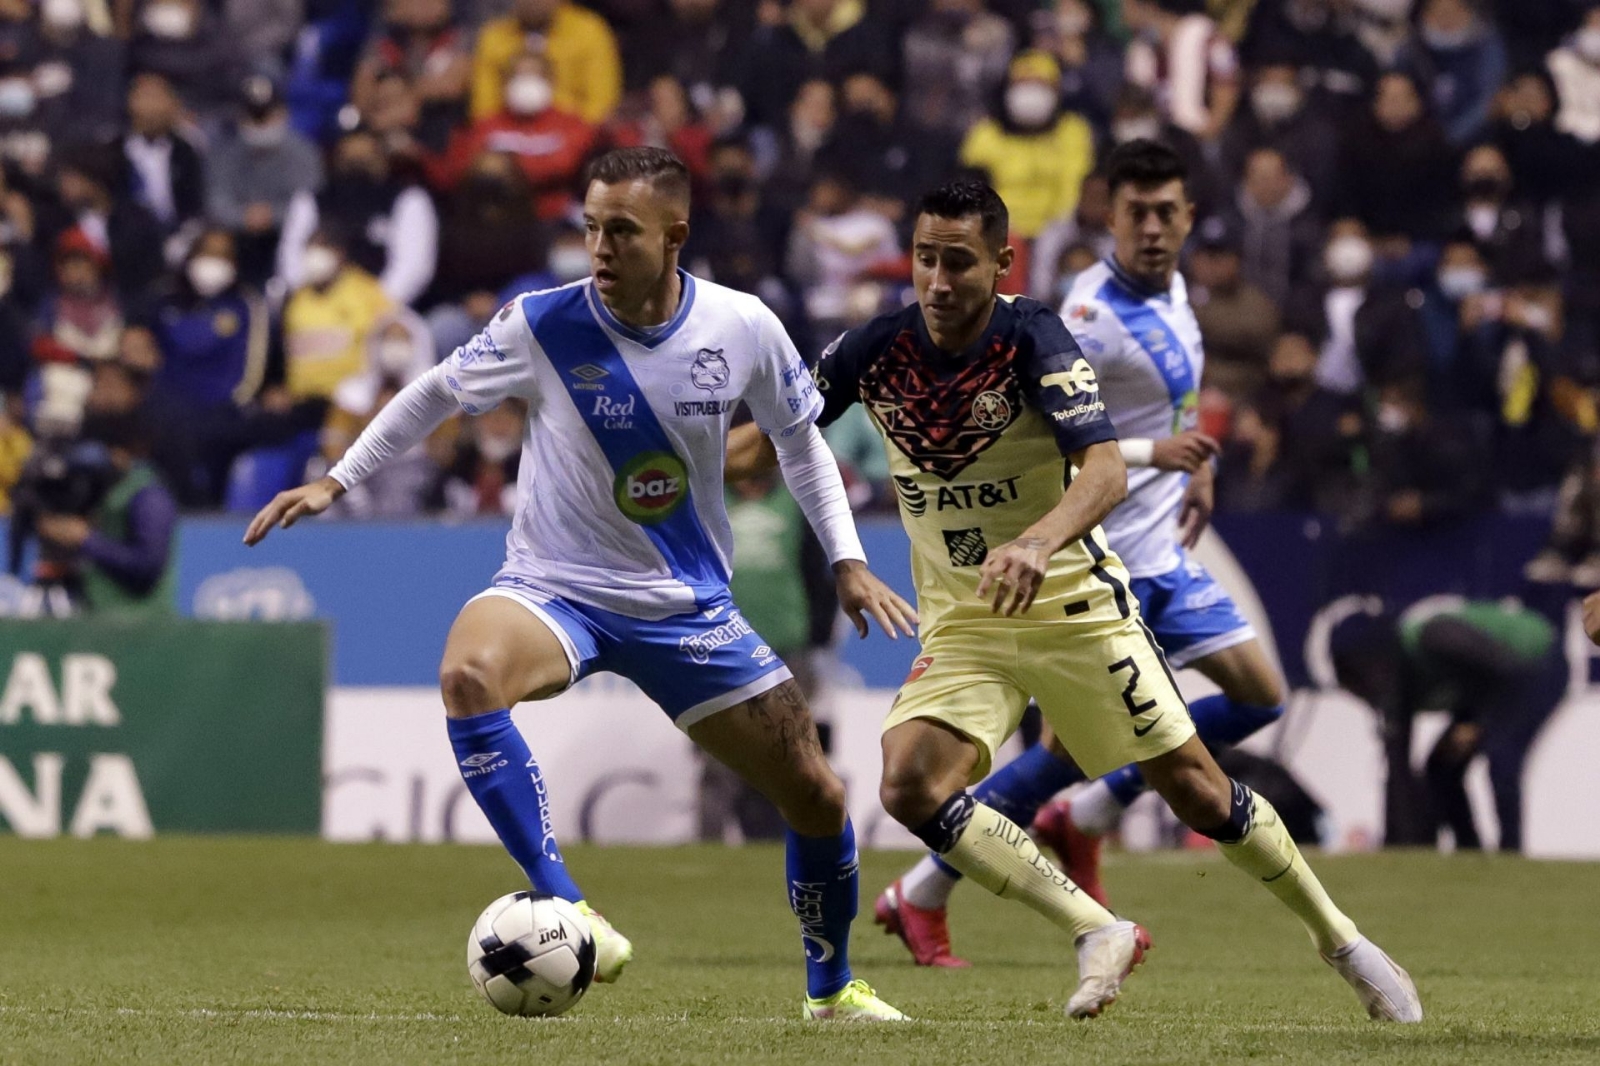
786, 820, 861, 999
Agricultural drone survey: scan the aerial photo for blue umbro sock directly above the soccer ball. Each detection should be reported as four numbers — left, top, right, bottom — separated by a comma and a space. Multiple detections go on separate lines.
445, 711, 584, 903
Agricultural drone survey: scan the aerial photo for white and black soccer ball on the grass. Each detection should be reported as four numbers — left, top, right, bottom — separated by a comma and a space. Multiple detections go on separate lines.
467, 892, 595, 1018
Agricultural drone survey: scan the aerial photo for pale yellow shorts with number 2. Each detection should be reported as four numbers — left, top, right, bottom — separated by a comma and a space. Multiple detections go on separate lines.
883, 611, 1195, 781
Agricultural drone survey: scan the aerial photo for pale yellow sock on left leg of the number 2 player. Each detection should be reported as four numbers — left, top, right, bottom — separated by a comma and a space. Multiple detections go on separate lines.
939, 804, 1117, 941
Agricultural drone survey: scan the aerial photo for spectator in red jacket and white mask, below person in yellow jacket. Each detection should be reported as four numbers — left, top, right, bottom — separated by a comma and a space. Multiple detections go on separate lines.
429, 53, 598, 219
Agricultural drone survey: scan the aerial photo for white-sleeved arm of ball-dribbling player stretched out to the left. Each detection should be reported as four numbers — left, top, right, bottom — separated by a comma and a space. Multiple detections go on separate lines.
245, 365, 458, 544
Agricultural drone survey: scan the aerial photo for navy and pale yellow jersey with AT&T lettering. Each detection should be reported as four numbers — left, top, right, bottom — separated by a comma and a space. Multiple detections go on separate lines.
816, 298, 1128, 640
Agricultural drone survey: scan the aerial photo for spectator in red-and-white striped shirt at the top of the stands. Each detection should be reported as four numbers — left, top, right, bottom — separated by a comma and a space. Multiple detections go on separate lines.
1122, 0, 1238, 141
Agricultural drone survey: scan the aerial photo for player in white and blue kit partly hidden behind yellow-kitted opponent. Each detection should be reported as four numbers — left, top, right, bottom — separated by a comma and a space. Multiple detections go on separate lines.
875, 141, 1283, 967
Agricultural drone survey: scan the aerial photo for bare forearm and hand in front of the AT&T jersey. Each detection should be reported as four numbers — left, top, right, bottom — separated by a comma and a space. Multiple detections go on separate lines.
978, 440, 1128, 616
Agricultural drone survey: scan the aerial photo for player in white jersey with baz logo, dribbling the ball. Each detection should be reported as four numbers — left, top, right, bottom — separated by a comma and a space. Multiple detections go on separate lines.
245, 149, 915, 1020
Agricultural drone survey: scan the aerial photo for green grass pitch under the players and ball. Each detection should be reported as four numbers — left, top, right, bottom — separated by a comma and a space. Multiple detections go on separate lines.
0, 837, 1600, 1066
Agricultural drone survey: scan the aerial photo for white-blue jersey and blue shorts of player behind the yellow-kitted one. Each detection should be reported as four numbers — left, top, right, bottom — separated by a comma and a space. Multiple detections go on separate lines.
1061, 261, 1256, 667
